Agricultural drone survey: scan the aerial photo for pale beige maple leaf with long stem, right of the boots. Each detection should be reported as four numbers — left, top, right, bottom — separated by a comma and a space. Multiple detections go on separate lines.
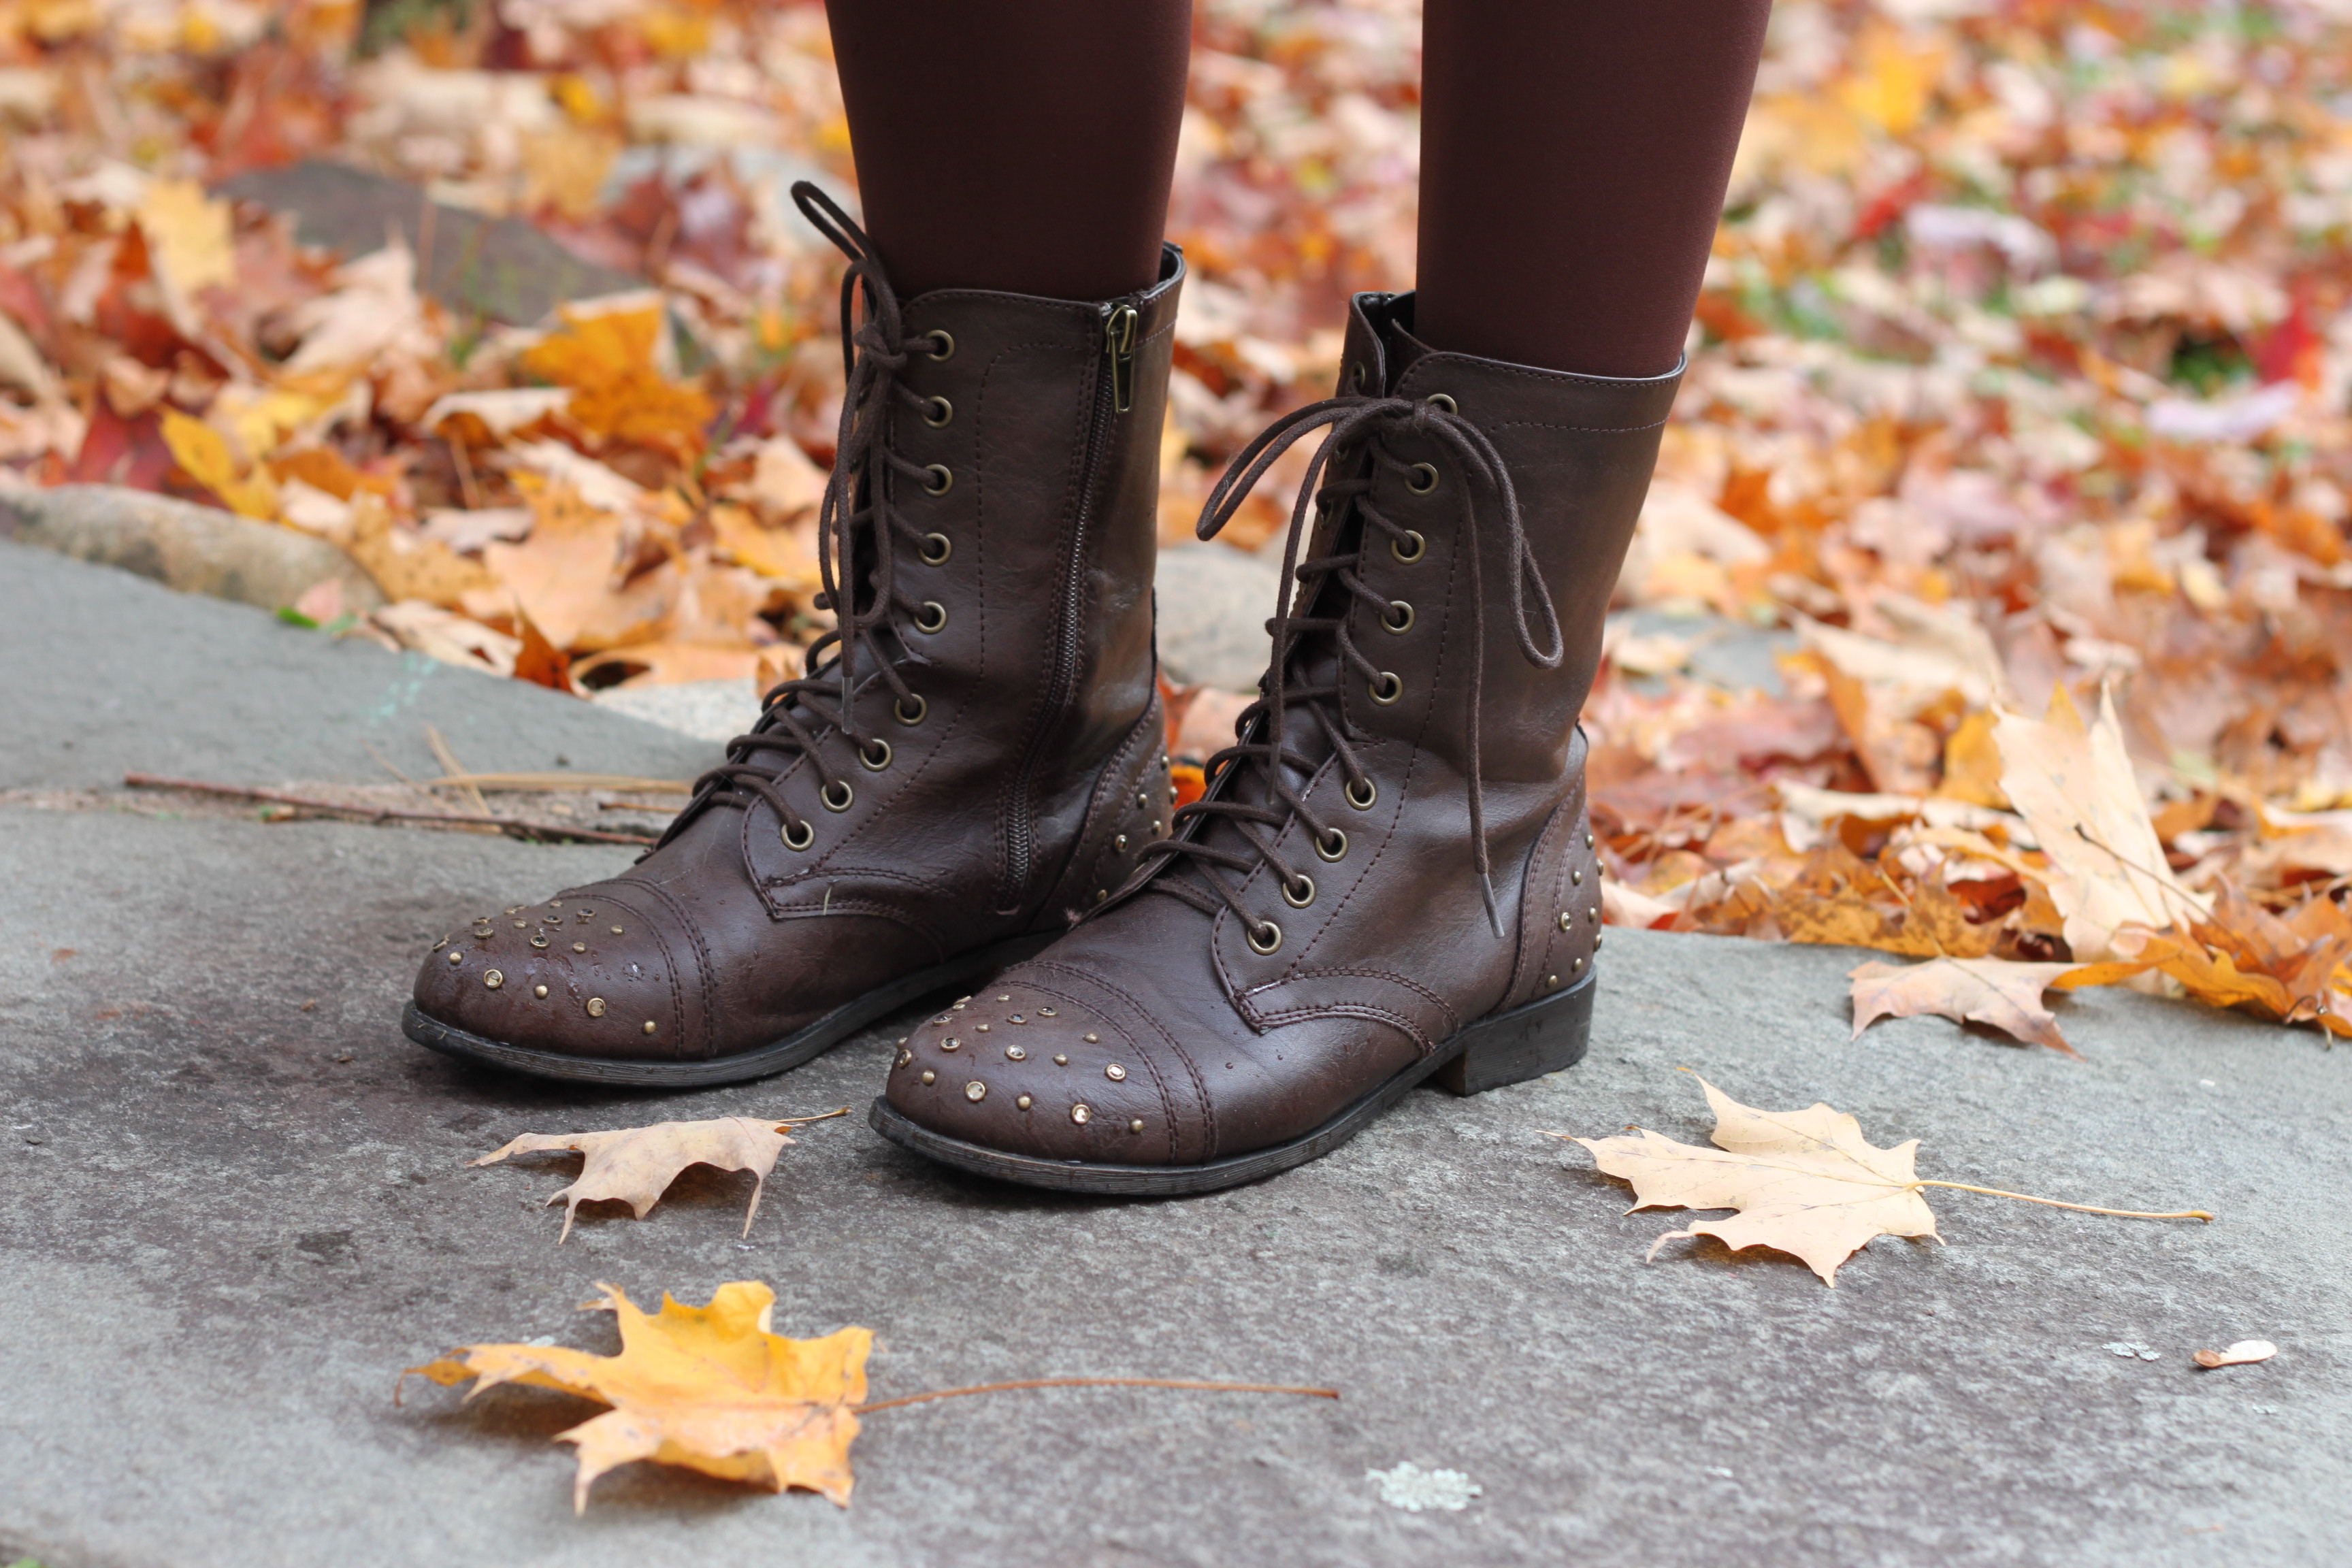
1546, 1079, 2213, 1288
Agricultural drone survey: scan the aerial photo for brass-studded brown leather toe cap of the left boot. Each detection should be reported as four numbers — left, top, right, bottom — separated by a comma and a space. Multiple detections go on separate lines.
416, 889, 685, 1058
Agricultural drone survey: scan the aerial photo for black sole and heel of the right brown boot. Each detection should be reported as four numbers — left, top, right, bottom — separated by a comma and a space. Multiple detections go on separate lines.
866, 971, 1599, 1196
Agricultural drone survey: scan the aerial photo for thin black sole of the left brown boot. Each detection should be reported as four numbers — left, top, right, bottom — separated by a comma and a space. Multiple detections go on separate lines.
400, 933, 1054, 1088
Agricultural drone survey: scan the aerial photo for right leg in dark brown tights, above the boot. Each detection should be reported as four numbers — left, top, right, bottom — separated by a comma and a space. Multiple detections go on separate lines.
1414, 0, 1771, 376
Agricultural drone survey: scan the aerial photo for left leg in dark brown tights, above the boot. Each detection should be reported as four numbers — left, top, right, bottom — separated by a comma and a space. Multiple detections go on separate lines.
826, 0, 1192, 299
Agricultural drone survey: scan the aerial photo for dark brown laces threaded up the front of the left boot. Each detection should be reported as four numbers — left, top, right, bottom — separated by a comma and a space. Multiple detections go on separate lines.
656, 181, 932, 849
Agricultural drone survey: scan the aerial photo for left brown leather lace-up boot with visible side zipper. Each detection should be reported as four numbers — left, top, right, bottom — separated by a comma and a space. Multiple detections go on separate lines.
402, 186, 1183, 1086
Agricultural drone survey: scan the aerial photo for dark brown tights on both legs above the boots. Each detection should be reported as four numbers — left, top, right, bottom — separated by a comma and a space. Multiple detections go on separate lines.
826, 0, 1771, 376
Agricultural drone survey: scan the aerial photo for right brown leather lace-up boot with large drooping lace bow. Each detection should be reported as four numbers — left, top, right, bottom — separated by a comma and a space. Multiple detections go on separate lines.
872, 294, 1682, 1194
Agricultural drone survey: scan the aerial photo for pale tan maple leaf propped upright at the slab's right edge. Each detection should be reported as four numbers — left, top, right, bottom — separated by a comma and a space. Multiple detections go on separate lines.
1995, 687, 2204, 959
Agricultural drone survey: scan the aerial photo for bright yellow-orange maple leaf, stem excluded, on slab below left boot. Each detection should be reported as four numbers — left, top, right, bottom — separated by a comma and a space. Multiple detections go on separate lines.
409, 1279, 872, 1512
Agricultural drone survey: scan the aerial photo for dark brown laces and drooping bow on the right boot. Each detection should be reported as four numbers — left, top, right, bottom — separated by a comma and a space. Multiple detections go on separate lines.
1136, 395, 1564, 938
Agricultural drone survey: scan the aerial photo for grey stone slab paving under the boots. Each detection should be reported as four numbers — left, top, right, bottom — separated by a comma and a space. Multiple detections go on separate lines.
0, 553, 2352, 1568
